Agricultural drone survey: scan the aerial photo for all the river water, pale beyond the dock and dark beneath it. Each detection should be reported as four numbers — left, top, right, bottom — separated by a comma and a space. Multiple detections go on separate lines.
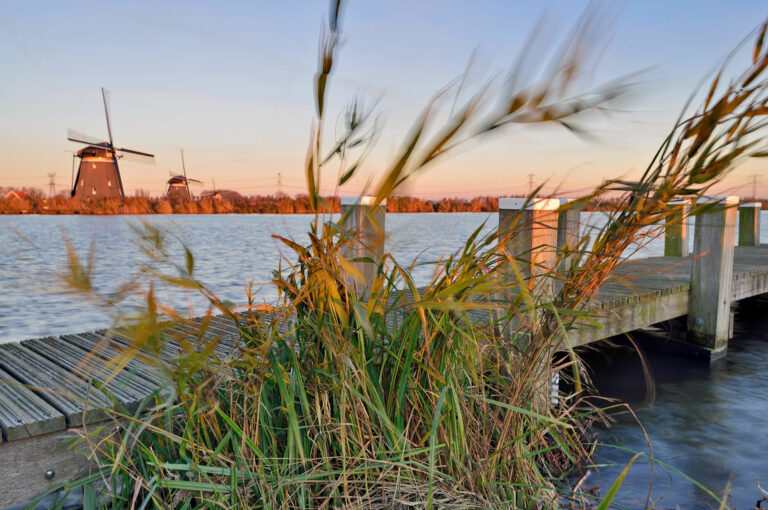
0, 212, 768, 508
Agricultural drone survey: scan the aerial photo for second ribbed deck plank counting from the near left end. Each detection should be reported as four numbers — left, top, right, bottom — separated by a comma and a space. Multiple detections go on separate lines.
0, 343, 111, 427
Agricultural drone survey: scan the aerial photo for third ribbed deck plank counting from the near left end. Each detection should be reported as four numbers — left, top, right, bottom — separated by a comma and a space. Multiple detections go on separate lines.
21, 337, 157, 411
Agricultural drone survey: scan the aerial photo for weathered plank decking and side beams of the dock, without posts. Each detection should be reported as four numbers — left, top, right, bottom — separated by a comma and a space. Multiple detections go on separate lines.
0, 197, 768, 508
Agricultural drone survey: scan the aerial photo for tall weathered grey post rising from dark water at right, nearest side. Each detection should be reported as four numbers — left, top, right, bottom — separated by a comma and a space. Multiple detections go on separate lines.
688, 196, 739, 359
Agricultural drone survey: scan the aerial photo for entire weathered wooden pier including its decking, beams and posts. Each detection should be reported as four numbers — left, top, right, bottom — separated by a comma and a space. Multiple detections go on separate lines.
0, 196, 768, 508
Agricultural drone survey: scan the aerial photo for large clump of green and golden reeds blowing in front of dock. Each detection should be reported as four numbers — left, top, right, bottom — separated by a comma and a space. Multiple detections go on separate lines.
36, 3, 768, 508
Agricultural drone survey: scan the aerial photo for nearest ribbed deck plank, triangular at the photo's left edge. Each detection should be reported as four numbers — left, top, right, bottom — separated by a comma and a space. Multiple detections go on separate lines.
0, 370, 66, 441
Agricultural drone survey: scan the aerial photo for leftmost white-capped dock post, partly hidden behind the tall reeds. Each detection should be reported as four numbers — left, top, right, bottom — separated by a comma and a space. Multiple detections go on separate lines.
340, 195, 387, 295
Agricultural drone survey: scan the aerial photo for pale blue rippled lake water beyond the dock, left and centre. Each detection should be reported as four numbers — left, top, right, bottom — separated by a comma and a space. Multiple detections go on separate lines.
0, 213, 504, 343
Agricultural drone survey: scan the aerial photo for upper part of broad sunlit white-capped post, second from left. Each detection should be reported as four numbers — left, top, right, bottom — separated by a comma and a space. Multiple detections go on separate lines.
499, 198, 560, 297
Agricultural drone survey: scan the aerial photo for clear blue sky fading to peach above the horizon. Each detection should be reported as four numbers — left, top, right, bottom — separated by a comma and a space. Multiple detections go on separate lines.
0, 0, 768, 198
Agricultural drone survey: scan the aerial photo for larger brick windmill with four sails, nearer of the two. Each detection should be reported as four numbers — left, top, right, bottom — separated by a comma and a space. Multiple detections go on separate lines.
67, 87, 155, 200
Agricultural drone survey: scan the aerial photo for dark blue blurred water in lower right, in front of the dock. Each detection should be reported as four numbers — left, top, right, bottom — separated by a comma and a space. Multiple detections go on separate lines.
585, 308, 768, 508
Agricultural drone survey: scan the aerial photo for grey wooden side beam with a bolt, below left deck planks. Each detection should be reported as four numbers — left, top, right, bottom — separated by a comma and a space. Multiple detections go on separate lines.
0, 431, 96, 508
